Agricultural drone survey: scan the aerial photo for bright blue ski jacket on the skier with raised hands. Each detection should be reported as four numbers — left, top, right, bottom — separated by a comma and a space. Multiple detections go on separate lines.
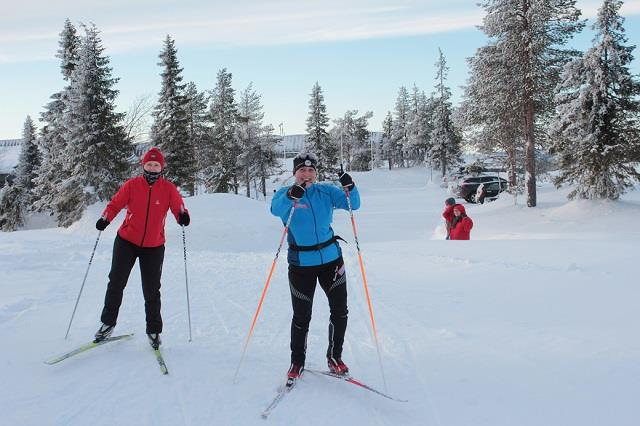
271, 183, 360, 266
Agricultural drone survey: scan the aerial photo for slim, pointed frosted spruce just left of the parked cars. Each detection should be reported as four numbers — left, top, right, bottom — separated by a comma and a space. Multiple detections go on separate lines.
429, 49, 462, 177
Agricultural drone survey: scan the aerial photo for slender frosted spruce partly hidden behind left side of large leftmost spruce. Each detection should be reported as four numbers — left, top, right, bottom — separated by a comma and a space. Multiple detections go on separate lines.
32, 19, 80, 215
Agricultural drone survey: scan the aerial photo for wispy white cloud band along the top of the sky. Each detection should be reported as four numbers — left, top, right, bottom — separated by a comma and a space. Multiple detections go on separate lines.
0, 0, 640, 62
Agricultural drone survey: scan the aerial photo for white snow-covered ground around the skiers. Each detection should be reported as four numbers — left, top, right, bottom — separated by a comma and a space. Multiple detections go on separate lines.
0, 168, 640, 426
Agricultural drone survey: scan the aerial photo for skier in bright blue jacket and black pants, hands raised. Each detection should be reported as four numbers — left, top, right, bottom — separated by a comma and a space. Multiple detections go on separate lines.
271, 153, 360, 379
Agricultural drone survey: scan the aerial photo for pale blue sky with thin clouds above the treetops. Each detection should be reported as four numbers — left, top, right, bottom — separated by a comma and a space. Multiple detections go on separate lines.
0, 0, 640, 139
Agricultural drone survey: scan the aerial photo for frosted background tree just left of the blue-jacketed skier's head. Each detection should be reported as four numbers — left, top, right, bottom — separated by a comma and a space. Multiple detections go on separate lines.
238, 83, 278, 197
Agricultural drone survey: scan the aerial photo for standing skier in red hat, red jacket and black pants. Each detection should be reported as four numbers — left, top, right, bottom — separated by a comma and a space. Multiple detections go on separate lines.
95, 148, 191, 349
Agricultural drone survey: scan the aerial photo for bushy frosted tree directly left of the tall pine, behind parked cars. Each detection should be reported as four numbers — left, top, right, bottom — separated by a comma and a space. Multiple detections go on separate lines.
459, 45, 524, 190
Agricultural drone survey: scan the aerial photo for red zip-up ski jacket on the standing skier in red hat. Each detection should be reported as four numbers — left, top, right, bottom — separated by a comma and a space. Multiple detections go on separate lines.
102, 176, 188, 247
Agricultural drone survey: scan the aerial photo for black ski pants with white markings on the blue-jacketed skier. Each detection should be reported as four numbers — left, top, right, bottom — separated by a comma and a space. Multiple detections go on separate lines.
289, 257, 349, 365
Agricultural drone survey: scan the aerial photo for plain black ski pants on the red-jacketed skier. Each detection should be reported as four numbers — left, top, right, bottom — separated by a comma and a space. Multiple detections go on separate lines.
100, 235, 164, 333
